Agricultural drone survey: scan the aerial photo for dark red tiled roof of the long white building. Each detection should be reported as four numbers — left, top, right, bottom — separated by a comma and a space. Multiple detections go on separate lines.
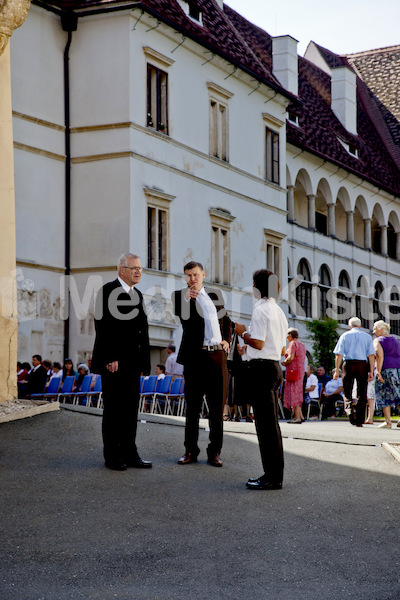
33, 0, 400, 195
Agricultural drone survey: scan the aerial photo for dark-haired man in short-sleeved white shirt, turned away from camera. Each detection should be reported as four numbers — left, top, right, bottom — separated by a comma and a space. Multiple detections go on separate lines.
235, 269, 288, 490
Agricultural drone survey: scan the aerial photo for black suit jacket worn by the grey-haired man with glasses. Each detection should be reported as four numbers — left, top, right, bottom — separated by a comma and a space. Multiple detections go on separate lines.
91, 279, 150, 374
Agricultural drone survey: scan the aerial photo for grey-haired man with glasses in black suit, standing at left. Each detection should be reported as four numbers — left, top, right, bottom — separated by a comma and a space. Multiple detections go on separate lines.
92, 253, 152, 471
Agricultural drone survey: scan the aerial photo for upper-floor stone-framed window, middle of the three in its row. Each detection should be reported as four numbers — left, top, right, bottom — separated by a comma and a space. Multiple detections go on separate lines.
207, 82, 233, 162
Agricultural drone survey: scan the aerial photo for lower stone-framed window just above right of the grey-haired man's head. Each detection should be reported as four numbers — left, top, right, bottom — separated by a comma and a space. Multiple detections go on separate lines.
144, 188, 174, 271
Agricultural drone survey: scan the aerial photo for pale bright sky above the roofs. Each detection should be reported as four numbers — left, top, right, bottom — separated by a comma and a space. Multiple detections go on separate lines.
224, 0, 400, 55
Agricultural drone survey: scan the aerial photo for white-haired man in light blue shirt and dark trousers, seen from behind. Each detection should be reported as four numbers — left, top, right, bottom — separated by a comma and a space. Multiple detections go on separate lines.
333, 317, 375, 427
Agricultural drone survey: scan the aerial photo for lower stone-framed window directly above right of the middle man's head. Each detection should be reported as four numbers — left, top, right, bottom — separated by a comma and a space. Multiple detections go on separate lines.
209, 208, 236, 285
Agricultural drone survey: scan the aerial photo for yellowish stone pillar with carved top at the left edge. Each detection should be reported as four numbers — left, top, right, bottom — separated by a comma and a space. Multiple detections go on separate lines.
0, 0, 30, 402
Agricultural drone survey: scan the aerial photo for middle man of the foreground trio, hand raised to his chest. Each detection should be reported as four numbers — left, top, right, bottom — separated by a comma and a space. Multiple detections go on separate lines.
172, 261, 232, 467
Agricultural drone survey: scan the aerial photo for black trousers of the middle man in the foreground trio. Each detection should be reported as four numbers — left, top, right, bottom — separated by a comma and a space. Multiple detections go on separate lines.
185, 350, 228, 456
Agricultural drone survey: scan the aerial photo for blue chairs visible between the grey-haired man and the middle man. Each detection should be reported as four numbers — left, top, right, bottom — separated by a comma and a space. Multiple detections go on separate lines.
139, 375, 185, 417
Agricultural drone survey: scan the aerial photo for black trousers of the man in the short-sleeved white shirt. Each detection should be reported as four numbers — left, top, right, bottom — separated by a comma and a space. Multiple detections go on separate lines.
249, 360, 284, 483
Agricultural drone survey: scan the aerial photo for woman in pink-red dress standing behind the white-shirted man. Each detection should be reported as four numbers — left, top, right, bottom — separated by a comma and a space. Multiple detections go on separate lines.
282, 327, 306, 424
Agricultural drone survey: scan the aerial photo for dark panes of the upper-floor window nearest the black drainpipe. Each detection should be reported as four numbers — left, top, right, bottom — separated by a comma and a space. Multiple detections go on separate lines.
147, 64, 168, 134
